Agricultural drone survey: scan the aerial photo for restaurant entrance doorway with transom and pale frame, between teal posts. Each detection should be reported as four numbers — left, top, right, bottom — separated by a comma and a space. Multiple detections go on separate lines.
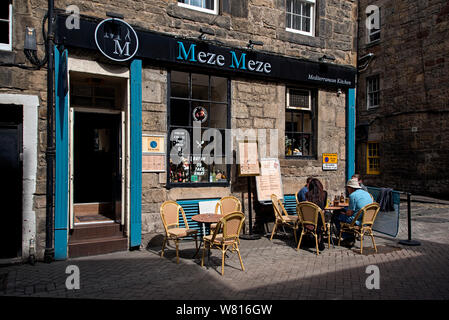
70, 73, 127, 227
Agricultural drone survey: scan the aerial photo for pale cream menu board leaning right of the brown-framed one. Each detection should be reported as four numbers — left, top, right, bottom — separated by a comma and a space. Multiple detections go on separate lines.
256, 158, 284, 202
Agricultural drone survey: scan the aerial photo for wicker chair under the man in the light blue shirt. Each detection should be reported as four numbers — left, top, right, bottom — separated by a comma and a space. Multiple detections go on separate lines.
338, 202, 380, 254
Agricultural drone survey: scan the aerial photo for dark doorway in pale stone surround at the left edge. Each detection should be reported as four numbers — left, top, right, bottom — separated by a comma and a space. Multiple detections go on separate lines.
0, 105, 23, 259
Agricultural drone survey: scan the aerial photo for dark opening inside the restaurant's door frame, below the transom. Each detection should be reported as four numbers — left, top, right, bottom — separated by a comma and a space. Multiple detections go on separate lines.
73, 112, 121, 223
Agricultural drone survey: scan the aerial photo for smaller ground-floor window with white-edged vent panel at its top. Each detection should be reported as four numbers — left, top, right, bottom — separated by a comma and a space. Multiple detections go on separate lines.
285, 89, 316, 157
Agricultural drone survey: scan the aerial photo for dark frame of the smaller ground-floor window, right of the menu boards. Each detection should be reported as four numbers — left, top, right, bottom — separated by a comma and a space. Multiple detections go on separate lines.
284, 86, 318, 160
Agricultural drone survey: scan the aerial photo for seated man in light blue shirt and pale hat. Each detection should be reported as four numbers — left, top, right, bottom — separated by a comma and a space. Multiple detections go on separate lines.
332, 179, 373, 247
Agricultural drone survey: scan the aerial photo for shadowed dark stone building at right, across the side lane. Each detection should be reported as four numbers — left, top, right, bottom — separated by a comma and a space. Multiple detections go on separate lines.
356, 0, 449, 198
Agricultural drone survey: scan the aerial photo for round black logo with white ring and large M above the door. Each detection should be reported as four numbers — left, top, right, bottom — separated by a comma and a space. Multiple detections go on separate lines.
95, 18, 139, 61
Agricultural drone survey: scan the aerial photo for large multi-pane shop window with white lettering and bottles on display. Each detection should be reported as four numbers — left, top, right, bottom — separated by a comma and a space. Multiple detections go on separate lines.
169, 71, 230, 186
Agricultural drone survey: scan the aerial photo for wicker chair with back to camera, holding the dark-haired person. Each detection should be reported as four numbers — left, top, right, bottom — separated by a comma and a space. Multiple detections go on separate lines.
296, 201, 331, 255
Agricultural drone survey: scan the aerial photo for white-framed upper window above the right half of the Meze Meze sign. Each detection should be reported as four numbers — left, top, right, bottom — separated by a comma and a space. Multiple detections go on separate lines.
286, 0, 316, 36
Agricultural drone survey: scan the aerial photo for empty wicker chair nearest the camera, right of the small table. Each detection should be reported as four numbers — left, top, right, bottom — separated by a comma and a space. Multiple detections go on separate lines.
201, 211, 245, 275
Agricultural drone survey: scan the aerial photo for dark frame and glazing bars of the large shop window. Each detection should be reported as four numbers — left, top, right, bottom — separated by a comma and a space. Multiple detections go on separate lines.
166, 69, 231, 189
